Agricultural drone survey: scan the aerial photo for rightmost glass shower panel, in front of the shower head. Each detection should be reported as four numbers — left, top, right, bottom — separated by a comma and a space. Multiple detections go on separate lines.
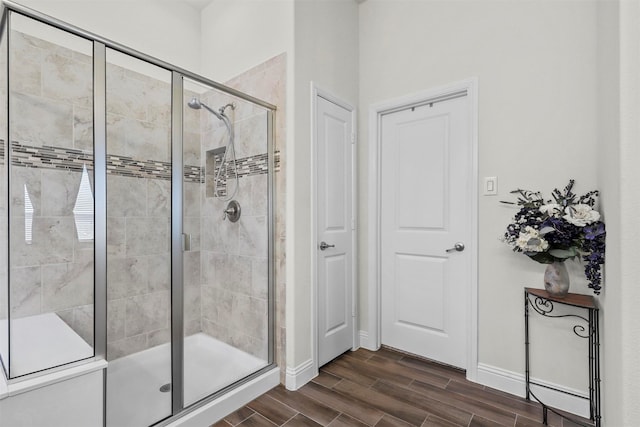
182, 79, 270, 406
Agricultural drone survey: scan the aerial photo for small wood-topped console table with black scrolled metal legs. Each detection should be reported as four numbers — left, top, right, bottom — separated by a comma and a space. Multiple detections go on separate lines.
524, 288, 602, 427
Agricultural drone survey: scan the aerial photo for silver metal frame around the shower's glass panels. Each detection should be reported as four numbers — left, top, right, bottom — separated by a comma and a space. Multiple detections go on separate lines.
0, 0, 276, 426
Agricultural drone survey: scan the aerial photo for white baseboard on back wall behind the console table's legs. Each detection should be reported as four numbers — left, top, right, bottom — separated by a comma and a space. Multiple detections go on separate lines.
477, 363, 589, 418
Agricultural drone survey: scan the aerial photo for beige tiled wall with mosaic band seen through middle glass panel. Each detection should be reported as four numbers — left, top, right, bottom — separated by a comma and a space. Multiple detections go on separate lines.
106, 59, 171, 360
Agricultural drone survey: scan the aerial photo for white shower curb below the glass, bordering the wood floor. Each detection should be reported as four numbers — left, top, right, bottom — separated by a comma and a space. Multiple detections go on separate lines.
167, 367, 280, 427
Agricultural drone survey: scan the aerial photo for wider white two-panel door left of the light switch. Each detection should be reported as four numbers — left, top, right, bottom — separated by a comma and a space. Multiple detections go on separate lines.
380, 96, 473, 368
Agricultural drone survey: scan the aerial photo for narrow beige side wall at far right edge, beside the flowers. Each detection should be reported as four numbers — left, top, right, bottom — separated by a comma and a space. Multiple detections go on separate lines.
601, 1, 640, 426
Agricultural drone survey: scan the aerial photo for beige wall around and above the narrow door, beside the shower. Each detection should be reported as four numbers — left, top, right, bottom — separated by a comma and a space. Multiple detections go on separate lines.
287, 0, 358, 367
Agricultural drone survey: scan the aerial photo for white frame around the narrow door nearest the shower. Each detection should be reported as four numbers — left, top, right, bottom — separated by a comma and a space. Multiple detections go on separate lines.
311, 81, 359, 375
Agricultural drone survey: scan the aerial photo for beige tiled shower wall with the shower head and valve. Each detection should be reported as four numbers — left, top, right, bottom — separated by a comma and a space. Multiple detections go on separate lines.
194, 92, 269, 360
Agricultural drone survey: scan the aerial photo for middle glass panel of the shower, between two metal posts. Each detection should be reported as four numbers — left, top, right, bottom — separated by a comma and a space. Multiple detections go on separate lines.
106, 49, 172, 427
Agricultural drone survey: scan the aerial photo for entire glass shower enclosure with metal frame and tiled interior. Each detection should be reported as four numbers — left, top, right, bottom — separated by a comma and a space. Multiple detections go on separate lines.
0, 2, 274, 427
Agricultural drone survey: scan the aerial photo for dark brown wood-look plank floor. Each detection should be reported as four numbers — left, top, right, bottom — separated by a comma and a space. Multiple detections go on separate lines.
212, 348, 588, 427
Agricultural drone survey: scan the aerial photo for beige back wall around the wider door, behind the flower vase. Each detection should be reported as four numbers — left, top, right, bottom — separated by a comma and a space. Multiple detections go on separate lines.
358, 0, 598, 388
